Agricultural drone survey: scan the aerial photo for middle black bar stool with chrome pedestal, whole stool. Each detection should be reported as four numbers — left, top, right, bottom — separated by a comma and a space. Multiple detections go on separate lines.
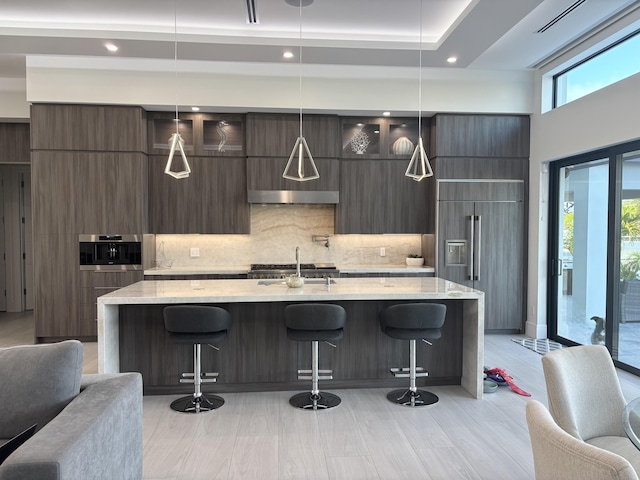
284, 303, 347, 410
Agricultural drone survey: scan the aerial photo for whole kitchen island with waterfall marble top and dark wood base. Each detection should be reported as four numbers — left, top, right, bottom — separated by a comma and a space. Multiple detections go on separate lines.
98, 277, 484, 398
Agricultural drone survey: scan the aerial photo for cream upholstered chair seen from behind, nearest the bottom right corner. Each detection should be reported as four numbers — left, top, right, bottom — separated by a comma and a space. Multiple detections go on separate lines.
526, 400, 638, 480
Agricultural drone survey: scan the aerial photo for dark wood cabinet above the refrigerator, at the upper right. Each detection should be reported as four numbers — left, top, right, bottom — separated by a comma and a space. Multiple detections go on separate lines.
432, 114, 529, 158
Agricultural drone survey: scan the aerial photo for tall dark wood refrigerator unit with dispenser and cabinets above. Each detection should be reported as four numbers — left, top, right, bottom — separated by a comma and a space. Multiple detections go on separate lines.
432, 114, 529, 332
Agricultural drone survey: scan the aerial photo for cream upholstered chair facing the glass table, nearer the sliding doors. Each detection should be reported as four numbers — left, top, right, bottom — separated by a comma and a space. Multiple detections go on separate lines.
542, 345, 640, 472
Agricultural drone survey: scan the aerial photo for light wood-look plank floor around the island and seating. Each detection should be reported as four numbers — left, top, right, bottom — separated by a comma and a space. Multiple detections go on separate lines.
0, 313, 640, 480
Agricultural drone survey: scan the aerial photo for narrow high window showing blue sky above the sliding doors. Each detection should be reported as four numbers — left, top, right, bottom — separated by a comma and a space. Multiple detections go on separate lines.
553, 32, 640, 108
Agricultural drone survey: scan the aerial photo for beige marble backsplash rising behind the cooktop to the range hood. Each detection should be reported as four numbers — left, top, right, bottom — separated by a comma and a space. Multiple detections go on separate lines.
156, 205, 422, 267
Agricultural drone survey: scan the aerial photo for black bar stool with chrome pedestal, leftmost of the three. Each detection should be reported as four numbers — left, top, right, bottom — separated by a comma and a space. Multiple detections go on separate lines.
163, 305, 231, 413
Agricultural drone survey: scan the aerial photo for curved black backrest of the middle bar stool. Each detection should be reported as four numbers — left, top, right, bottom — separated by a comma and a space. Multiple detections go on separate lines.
284, 303, 347, 330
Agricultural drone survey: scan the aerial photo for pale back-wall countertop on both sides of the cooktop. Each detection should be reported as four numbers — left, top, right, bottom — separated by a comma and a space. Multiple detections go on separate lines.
144, 265, 435, 277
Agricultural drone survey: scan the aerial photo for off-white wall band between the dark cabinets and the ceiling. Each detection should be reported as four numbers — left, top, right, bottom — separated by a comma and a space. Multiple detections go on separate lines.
21, 57, 533, 116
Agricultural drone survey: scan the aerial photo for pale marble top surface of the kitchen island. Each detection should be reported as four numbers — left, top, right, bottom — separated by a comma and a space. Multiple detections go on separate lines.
98, 277, 484, 307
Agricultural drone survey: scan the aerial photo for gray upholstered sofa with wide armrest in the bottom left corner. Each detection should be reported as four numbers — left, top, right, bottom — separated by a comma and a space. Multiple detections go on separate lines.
0, 340, 142, 480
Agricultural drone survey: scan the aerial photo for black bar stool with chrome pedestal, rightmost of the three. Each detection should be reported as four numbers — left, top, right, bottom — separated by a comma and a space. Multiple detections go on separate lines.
380, 303, 447, 407
